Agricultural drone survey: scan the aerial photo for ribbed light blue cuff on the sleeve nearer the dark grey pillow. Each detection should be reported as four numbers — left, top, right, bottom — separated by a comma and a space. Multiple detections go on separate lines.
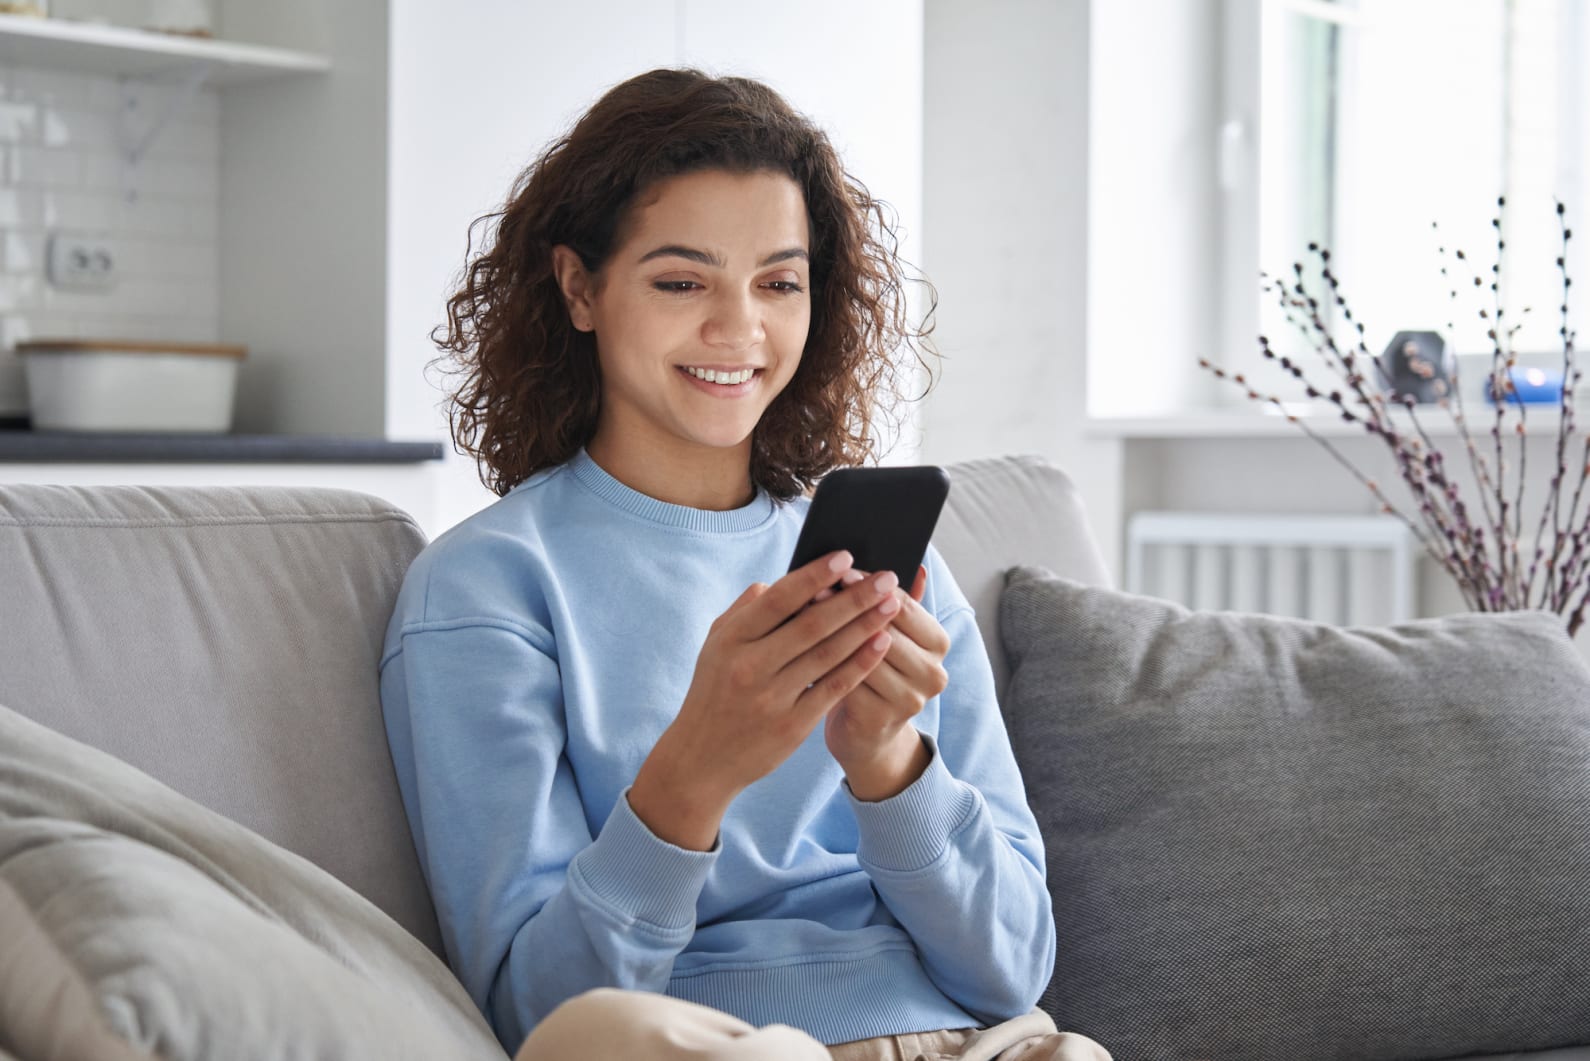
844, 733, 979, 873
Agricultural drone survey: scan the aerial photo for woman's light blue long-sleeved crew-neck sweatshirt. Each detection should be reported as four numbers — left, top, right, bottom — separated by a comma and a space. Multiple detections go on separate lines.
380, 452, 1054, 1051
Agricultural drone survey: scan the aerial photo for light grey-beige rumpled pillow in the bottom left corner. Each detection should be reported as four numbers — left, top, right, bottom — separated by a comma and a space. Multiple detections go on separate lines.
0, 708, 504, 1061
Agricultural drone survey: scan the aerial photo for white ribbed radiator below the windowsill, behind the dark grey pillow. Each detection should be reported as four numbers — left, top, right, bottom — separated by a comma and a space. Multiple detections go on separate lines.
1126, 512, 1418, 625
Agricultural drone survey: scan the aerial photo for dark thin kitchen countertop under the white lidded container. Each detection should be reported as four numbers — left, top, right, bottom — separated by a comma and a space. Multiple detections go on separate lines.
0, 429, 442, 464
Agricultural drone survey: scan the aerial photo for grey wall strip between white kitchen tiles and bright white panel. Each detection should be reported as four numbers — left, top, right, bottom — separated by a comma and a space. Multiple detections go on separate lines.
219, 0, 387, 437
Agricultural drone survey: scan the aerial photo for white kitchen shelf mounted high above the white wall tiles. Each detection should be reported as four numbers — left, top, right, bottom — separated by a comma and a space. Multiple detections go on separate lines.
0, 14, 331, 86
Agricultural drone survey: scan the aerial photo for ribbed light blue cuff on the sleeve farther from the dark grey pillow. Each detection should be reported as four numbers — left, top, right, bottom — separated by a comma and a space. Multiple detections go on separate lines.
569, 789, 719, 929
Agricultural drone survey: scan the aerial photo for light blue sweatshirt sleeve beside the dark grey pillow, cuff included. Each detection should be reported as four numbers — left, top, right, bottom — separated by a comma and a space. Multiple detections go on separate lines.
851, 553, 1056, 1023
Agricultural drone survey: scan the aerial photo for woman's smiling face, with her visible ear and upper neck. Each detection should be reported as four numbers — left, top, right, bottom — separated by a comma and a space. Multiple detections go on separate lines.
553, 170, 811, 496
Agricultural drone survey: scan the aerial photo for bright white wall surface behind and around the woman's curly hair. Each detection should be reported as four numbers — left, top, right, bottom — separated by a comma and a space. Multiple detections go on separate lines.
386, 0, 922, 533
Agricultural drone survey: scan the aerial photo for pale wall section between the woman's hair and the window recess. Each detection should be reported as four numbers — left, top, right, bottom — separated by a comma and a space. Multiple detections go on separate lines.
922, 0, 1121, 582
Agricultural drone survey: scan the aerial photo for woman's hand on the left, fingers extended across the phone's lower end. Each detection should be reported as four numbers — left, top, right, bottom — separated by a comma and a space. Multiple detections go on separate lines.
630, 552, 903, 851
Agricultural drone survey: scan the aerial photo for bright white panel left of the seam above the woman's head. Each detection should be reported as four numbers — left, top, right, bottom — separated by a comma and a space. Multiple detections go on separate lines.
386, 0, 674, 536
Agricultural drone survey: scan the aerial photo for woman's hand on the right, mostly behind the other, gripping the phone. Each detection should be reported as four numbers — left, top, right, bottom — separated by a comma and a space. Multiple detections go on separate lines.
824, 568, 949, 802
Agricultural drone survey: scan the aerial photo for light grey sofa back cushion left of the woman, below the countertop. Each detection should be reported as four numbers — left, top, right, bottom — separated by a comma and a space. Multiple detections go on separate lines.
0, 485, 440, 953
